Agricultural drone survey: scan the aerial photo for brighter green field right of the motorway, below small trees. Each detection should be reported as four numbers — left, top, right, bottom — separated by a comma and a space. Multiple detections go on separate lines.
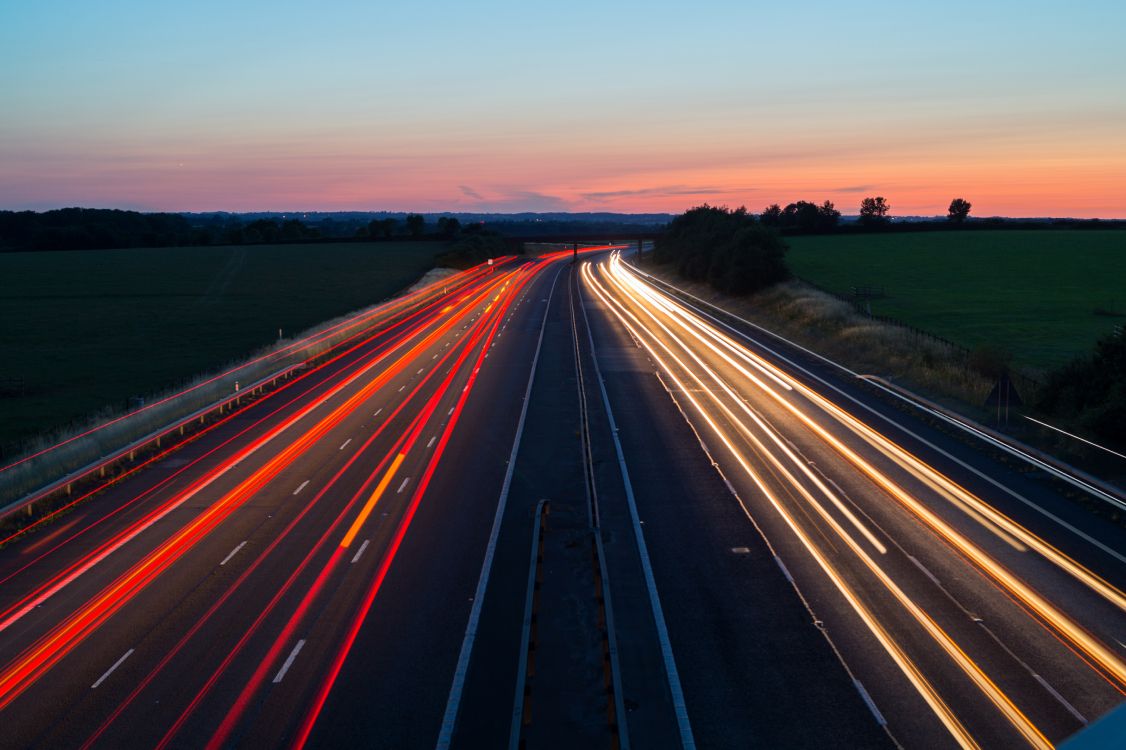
787, 230, 1126, 370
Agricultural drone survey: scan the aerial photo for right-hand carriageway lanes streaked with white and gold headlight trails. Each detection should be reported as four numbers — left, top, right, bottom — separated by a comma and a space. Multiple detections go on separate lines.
582, 253, 1126, 748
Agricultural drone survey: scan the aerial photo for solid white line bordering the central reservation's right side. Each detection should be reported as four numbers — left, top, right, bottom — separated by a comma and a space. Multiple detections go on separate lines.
579, 266, 696, 750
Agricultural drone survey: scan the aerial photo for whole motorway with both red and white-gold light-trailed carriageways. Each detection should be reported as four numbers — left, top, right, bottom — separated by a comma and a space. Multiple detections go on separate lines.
0, 248, 1126, 748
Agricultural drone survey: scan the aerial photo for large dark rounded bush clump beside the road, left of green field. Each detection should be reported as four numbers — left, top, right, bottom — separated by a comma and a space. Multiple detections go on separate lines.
653, 204, 790, 294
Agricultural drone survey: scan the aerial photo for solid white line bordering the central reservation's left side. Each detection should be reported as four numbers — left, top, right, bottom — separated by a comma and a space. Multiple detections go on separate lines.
436, 266, 563, 750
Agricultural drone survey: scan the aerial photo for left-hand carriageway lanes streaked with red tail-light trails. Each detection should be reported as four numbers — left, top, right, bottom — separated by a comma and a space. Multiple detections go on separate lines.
0, 246, 612, 747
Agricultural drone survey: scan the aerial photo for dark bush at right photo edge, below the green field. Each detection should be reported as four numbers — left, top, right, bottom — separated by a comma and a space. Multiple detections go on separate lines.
1037, 332, 1126, 450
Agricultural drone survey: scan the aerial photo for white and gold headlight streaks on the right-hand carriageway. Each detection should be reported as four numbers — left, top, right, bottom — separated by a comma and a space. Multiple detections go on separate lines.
582, 253, 1126, 748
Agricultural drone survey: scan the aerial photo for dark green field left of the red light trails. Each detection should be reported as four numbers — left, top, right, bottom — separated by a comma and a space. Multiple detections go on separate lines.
0, 242, 446, 452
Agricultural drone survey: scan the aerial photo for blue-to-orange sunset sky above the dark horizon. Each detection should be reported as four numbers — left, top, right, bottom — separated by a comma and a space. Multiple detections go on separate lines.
0, 0, 1126, 217
